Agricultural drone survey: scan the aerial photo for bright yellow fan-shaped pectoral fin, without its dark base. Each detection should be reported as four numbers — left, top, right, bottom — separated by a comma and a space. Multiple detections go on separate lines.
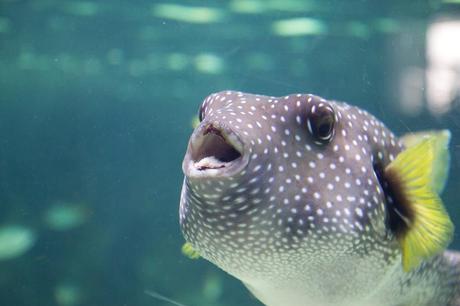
385, 135, 454, 272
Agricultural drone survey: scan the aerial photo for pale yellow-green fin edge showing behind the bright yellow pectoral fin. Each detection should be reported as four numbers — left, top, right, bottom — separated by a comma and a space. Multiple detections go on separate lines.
401, 130, 451, 194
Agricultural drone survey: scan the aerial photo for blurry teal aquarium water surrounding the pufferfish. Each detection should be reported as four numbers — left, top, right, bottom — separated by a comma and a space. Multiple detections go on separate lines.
0, 0, 460, 306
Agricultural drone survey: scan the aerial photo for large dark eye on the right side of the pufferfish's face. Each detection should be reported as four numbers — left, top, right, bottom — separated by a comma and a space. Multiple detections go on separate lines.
307, 103, 335, 144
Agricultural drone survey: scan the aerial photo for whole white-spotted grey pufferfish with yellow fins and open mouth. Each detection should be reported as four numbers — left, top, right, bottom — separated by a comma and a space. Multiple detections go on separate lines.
179, 91, 460, 306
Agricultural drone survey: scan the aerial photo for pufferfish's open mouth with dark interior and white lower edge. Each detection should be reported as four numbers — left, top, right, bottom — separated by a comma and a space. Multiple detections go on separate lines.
186, 124, 243, 175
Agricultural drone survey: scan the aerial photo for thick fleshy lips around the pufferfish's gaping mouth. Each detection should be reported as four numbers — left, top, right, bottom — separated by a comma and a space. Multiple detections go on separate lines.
182, 122, 249, 178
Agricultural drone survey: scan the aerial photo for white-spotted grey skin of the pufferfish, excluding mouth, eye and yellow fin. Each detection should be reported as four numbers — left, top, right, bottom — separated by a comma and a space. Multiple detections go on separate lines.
180, 91, 460, 306
